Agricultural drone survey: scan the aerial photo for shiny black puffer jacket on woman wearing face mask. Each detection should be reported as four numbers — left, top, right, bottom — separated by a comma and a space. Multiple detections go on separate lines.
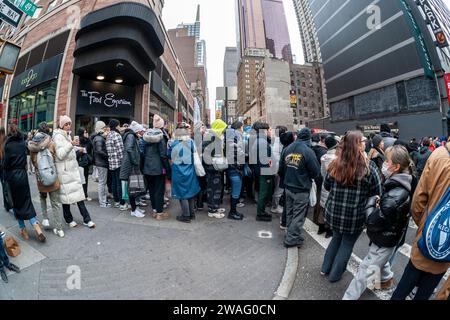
367, 173, 413, 248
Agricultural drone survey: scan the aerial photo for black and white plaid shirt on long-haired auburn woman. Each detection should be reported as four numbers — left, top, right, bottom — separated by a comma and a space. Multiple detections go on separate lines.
324, 161, 383, 234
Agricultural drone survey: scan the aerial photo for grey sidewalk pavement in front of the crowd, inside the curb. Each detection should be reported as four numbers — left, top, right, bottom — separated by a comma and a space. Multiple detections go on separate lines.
0, 176, 286, 300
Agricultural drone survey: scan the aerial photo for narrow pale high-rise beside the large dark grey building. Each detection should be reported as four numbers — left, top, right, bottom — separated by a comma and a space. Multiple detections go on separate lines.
293, 0, 322, 63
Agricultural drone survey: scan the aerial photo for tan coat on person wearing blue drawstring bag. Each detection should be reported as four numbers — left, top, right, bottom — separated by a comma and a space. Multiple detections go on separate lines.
411, 147, 450, 275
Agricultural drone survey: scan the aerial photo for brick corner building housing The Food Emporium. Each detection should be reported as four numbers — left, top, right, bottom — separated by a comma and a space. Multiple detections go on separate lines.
2, 0, 193, 132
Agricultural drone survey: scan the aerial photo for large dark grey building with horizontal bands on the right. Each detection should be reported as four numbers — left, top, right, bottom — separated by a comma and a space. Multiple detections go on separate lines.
309, 0, 450, 139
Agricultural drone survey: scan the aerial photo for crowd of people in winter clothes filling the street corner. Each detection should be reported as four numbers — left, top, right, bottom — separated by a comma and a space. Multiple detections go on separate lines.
0, 115, 450, 300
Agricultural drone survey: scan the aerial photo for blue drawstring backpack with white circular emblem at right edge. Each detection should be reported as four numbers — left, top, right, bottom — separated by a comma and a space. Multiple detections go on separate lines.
418, 188, 450, 263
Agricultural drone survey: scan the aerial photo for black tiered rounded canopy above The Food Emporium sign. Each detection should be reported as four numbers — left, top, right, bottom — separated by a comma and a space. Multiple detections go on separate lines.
73, 2, 165, 86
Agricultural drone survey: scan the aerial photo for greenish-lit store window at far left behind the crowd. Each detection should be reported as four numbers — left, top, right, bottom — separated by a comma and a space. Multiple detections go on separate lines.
8, 81, 57, 132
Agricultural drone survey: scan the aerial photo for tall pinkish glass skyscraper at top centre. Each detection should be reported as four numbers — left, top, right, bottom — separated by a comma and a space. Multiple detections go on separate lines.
237, 0, 292, 63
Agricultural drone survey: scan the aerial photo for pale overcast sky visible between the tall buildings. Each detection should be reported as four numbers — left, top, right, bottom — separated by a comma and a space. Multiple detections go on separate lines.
163, 0, 450, 120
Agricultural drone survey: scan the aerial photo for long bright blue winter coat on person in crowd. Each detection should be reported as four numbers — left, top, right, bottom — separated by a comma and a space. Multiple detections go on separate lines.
168, 139, 200, 200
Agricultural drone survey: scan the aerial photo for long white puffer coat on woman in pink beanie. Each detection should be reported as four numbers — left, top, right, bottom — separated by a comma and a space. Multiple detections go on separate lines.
53, 129, 86, 204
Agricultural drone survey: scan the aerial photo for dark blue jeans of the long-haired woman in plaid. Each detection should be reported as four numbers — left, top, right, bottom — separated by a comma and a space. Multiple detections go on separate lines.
322, 230, 361, 282
